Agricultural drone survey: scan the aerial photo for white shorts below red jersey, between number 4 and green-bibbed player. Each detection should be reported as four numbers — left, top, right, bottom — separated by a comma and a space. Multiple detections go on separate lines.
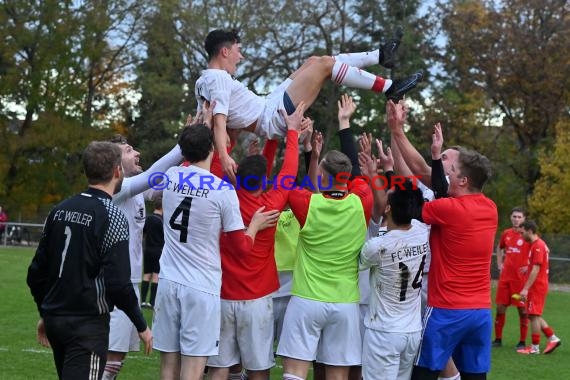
208, 295, 275, 371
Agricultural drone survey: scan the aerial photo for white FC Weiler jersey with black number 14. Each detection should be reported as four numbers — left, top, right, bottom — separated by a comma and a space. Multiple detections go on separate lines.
360, 219, 429, 333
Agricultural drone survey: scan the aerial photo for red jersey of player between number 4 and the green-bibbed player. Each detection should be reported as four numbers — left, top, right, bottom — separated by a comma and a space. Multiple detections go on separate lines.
220, 131, 299, 300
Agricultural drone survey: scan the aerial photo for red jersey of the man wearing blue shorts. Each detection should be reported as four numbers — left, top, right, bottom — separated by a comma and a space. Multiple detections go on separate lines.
422, 193, 498, 309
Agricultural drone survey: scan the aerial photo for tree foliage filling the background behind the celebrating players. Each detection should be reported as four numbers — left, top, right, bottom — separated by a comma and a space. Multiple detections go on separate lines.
0, 0, 570, 229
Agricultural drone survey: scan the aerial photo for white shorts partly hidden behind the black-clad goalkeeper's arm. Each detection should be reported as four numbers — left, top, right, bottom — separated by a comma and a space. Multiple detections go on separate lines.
109, 284, 141, 352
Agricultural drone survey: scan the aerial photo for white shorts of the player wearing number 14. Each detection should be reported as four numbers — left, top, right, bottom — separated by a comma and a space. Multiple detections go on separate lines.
362, 329, 422, 380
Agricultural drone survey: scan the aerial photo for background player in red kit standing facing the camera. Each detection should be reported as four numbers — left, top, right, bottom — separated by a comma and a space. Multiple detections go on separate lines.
493, 207, 529, 350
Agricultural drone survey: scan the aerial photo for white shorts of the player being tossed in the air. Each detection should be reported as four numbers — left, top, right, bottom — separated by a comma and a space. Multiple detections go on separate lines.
255, 78, 293, 139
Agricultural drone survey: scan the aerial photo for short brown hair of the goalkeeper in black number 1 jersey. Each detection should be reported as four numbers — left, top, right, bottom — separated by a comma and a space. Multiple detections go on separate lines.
82, 141, 121, 185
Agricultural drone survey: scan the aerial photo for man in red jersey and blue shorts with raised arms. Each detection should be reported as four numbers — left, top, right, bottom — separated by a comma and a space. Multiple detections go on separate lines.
412, 148, 498, 380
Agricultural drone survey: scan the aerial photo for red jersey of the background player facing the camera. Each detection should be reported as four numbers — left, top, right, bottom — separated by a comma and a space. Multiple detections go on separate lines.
499, 228, 530, 281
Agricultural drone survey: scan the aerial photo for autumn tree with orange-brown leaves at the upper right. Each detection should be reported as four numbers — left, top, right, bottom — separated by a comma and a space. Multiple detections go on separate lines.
418, 0, 570, 206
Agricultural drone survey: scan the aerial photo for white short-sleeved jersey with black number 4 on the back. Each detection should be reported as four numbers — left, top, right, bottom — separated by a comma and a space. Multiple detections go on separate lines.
159, 165, 244, 295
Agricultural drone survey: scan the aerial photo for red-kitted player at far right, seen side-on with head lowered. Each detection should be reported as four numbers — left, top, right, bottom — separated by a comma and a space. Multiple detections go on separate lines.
517, 220, 561, 355
